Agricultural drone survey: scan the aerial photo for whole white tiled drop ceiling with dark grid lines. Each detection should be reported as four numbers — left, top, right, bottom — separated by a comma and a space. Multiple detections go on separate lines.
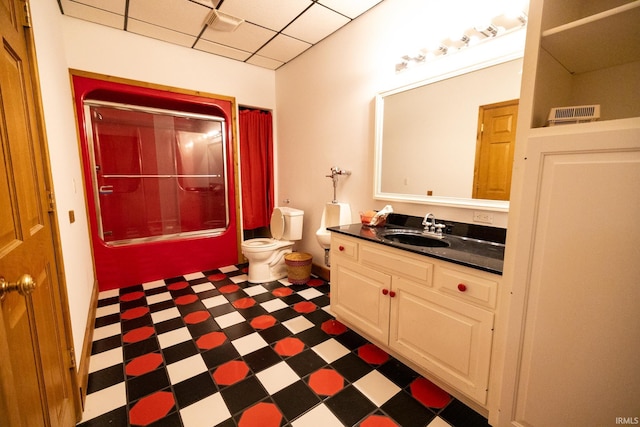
58, 0, 383, 70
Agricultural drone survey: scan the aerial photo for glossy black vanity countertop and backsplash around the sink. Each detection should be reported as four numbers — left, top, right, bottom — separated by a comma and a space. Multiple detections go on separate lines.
328, 214, 506, 275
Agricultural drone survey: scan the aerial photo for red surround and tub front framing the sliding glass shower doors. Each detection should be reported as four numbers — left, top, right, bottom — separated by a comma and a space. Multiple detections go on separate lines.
70, 70, 241, 291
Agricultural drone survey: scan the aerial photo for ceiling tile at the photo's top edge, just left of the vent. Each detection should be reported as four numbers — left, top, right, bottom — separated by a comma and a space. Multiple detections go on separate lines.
129, 0, 211, 36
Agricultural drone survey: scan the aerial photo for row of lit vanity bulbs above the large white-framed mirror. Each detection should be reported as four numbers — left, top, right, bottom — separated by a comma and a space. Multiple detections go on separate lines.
396, 11, 527, 73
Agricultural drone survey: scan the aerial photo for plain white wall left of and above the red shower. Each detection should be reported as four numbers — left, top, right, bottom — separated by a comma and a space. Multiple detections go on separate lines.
31, 4, 275, 362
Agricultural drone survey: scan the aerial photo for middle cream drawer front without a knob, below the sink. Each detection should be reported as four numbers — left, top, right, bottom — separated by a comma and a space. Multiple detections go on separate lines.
360, 245, 433, 286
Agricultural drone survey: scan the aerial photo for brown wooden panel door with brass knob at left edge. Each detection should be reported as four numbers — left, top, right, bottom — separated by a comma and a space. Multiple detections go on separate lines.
0, 0, 76, 427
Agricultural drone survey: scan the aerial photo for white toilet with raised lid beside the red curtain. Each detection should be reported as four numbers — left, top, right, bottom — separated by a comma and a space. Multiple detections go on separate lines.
242, 207, 304, 283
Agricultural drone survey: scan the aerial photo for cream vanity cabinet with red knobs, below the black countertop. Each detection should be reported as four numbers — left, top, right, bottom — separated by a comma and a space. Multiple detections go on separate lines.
331, 233, 500, 408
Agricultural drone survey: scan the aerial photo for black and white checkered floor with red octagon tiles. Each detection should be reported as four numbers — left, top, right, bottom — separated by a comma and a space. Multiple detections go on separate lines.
79, 265, 488, 427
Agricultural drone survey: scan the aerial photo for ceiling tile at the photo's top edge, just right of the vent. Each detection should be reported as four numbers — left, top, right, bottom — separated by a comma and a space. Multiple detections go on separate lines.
220, 0, 311, 31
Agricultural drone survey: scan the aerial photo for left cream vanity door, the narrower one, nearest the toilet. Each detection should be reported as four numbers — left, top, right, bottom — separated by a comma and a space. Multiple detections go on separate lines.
331, 257, 391, 344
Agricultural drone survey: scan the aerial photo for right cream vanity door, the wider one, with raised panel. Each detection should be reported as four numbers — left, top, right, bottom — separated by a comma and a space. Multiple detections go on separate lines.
389, 277, 494, 405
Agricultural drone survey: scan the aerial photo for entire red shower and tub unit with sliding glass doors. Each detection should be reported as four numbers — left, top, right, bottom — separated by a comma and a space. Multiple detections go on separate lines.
73, 75, 239, 290
